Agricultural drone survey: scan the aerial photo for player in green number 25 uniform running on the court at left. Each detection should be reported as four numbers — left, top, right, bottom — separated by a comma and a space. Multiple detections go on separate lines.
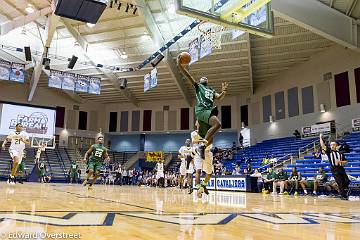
83, 136, 110, 189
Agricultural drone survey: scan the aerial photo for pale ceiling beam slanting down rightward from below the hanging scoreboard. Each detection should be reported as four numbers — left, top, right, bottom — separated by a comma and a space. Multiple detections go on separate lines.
62, 18, 139, 106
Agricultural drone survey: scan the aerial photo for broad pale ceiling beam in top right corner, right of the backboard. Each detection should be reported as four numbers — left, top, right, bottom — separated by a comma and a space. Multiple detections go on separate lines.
271, 0, 360, 50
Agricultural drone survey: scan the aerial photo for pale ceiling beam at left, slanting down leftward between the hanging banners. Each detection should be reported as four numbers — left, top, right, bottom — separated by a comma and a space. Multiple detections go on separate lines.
28, 13, 60, 102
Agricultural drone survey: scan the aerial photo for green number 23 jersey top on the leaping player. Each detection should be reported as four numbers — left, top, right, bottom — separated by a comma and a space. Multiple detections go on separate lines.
194, 83, 216, 110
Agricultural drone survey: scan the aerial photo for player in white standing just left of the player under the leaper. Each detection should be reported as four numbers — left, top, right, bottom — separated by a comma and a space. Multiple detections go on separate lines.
179, 139, 194, 194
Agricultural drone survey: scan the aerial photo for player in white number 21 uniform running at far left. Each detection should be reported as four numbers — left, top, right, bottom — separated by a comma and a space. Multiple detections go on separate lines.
2, 123, 30, 184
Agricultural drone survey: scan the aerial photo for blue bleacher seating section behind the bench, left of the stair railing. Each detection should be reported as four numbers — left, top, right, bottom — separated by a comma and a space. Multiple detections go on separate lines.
228, 137, 316, 171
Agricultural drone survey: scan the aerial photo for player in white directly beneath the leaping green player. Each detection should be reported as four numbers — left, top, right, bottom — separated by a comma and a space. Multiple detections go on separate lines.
191, 121, 213, 198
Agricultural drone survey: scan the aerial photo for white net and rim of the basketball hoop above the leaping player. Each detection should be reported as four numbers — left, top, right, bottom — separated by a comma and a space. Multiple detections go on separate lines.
197, 21, 226, 49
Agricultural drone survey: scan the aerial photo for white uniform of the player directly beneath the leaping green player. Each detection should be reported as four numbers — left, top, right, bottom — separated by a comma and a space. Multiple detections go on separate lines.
191, 128, 214, 174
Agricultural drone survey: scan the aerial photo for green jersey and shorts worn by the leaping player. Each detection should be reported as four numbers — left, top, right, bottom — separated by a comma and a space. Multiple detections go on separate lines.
194, 83, 218, 137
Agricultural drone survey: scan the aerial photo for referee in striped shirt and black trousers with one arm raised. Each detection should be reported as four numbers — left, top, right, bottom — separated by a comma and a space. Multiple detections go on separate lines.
320, 134, 350, 200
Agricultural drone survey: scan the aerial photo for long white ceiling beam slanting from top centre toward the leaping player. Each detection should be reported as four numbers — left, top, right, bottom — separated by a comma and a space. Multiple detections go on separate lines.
136, 0, 192, 106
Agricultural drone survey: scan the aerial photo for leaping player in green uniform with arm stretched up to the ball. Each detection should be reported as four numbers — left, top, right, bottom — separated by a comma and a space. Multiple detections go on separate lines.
177, 55, 228, 159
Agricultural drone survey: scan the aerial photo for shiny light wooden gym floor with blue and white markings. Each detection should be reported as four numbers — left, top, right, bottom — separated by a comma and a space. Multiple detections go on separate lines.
0, 182, 360, 240
